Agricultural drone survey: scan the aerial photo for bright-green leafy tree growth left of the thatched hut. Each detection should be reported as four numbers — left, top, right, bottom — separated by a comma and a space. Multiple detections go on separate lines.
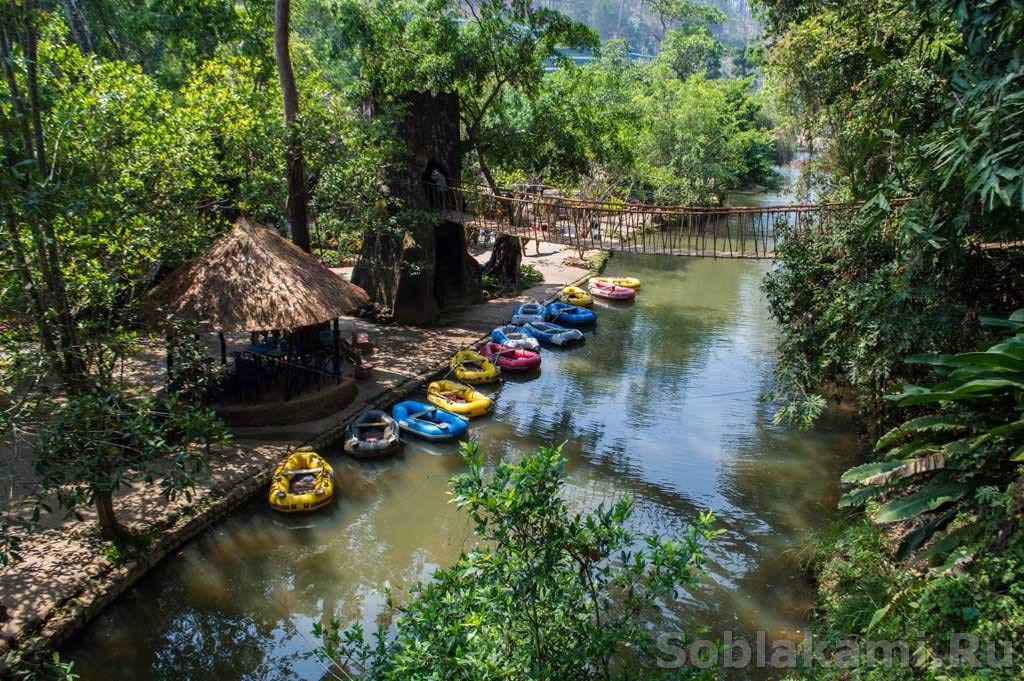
0, 0, 237, 540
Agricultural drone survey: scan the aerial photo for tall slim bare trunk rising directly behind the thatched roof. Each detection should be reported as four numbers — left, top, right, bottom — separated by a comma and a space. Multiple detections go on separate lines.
273, 0, 310, 253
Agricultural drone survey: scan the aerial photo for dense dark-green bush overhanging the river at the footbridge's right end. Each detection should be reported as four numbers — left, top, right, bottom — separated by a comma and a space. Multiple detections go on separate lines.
764, 204, 966, 427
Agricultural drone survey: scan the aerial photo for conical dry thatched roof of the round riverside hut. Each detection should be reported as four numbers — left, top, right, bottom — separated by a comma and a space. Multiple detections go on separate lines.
145, 217, 369, 332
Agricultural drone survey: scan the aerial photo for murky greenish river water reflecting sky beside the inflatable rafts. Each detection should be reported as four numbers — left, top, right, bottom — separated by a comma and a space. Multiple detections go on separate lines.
65, 163, 856, 681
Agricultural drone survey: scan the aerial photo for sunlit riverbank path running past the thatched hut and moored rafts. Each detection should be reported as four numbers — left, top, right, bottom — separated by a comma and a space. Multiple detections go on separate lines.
0, 244, 602, 654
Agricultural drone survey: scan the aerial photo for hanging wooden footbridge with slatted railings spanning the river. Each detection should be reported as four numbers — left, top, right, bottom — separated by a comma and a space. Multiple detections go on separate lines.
425, 182, 905, 259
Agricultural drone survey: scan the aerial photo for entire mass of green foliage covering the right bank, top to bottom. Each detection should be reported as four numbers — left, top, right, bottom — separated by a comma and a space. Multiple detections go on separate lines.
766, 0, 1024, 667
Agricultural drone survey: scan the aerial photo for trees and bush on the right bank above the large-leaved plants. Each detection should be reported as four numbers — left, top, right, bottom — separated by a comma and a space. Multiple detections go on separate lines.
766, 0, 1024, 423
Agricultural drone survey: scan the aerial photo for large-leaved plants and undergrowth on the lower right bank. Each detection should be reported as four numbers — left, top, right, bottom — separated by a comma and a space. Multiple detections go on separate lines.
794, 310, 1024, 678
